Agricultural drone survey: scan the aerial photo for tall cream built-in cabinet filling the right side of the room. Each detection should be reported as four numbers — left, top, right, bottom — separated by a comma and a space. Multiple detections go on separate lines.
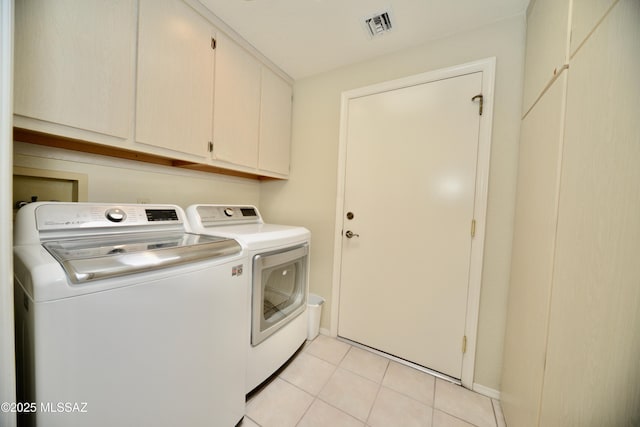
501, 0, 640, 427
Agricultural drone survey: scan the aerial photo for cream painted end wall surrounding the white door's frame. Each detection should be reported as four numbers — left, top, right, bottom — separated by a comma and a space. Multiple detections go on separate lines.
260, 16, 525, 390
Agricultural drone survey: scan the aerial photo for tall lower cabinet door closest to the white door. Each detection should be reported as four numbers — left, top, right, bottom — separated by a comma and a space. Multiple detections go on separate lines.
500, 71, 567, 427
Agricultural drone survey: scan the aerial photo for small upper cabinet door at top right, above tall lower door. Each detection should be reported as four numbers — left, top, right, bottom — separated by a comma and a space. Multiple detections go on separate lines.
522, 0, 570, 115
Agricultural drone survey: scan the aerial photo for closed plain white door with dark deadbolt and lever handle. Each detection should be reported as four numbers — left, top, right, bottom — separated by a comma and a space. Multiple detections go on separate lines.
338, 72, 482, 378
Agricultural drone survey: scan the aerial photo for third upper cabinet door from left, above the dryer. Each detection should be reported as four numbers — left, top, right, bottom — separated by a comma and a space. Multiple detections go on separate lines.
213, 34, 261, 168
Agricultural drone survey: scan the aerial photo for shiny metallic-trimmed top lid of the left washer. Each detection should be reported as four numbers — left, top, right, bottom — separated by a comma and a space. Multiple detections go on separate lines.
42, 232, 242, 284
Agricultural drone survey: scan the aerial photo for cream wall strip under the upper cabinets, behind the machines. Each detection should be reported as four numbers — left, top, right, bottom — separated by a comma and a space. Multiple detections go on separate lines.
13, 142, 260, 208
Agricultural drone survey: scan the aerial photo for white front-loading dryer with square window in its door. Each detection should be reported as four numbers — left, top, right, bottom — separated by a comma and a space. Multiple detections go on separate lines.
186, 204, 311, 393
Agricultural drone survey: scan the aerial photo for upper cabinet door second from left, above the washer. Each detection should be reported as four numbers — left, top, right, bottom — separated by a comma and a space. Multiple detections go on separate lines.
136, 0, 215, 157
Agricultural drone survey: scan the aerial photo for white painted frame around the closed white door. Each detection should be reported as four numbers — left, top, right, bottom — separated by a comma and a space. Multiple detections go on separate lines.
329, 57, 496, 389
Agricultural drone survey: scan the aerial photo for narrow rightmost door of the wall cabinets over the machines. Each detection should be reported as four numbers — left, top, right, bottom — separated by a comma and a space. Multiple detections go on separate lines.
258, 67, 292, 175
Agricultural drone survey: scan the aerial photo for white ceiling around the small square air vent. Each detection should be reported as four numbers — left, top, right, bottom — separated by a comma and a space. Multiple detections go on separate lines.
199, 0, 529, 79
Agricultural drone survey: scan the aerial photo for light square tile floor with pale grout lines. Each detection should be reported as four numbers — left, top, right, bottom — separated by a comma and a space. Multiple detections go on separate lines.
240, 335, 505, 427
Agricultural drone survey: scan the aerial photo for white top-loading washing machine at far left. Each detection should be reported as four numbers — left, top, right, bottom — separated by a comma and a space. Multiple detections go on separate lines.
14, 202, 249, 427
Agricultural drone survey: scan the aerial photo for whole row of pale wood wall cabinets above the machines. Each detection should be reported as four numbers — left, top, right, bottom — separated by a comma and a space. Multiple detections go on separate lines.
14, 0, 292, 178
